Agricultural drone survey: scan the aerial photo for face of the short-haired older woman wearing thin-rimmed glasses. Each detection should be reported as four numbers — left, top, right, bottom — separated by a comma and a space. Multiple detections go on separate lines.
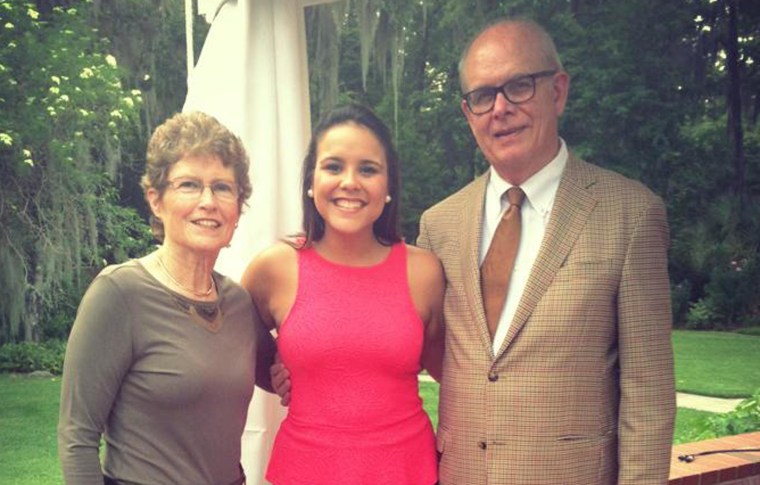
146, 155, 240, 253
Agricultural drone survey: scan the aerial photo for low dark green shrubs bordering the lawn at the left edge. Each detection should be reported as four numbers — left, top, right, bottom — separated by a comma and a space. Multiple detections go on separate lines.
0, 340, 66, 375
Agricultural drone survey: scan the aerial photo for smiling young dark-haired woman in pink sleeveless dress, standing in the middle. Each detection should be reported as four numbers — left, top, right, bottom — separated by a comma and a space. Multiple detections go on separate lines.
242, 105, 444, 485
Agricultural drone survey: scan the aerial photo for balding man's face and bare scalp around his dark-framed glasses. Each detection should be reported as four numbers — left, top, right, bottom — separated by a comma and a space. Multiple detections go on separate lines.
462, 24, 569, 185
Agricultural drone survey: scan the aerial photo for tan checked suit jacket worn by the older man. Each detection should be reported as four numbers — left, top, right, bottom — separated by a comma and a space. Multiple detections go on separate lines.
418, 155, 675, 485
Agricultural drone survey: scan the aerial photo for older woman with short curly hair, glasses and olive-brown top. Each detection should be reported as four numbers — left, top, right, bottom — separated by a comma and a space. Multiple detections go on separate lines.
58, 113, 273, 485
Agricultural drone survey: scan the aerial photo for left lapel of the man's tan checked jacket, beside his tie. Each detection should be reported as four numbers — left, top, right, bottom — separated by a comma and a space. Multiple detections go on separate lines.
460, 171, 493, 355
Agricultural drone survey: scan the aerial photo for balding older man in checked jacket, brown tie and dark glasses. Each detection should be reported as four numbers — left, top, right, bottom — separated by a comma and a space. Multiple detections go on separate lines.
418, 19, 675, 485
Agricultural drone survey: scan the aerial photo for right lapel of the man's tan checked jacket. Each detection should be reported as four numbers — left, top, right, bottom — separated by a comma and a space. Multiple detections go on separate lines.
496, 154, 597, 358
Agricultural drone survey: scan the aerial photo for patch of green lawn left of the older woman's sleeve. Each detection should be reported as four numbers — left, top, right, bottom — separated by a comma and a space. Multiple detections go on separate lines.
0, 374, 63, 485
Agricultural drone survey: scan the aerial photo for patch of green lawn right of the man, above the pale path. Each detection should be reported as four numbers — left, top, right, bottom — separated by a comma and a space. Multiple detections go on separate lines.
673, 330, 760, 398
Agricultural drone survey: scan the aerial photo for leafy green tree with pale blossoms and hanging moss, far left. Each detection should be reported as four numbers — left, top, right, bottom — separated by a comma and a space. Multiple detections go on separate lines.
0, 0, 150, 343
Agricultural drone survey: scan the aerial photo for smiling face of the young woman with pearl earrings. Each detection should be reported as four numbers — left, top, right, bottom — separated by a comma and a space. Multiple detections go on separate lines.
312, 122, 388, 240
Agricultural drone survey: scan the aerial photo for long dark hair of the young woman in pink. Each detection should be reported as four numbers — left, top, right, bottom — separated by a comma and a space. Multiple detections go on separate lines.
298, 104, 401, 247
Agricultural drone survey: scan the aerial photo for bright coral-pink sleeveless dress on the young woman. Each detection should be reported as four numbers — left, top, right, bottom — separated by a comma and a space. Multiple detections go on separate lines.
266, 243, 437, 485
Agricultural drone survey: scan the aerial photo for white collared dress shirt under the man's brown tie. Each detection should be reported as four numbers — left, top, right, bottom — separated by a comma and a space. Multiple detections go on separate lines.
478, 139, 568, 355
